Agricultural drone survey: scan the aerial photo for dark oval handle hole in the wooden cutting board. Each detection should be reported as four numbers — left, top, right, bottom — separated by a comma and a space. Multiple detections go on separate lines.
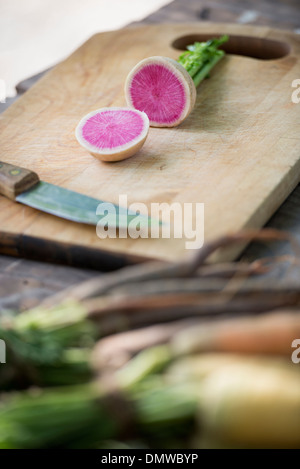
171, 33, 290, 60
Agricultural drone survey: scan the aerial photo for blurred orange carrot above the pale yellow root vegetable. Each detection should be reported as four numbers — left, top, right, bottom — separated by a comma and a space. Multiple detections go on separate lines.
171, 310, 300, 355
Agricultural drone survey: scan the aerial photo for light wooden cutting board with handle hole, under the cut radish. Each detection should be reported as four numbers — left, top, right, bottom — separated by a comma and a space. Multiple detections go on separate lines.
0, 23, 300, 267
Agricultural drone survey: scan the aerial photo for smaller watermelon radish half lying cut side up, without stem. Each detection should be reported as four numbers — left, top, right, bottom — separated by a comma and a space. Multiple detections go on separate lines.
75, 107, 149, 161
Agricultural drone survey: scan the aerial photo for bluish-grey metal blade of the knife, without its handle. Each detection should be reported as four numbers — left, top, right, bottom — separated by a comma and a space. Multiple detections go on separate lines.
16, 182, 152, 228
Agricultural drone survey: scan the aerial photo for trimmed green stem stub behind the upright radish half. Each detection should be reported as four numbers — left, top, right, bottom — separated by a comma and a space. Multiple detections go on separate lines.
178, 36, 229, 88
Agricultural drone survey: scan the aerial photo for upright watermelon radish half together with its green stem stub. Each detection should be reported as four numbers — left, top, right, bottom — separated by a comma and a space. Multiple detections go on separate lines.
125, 35, 229, 127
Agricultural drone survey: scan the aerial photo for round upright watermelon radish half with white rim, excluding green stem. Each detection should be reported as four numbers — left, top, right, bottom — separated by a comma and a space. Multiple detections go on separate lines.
125, 56, 197, 127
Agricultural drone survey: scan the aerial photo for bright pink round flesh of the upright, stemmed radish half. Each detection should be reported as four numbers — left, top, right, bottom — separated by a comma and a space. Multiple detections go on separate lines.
130, 64, 186, 124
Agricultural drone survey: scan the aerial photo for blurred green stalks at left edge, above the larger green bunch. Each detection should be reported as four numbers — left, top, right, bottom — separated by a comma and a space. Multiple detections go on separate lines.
0, 302, 98, 390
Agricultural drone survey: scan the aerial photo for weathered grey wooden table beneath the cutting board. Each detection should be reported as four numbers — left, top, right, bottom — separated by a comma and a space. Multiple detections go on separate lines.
0, 0, 300, 311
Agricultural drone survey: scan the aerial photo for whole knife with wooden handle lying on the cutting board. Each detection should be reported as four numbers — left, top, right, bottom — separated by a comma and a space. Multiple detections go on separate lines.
0, 161, 154, 228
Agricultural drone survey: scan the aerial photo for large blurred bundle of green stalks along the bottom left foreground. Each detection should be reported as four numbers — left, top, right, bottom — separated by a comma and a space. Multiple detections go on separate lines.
0, 346, 197, 449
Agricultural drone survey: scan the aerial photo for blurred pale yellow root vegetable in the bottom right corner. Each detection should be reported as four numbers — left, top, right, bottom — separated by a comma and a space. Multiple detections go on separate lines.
199, 364, 300, 448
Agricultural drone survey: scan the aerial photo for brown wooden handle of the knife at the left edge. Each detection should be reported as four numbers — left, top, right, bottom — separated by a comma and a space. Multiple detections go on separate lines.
0, 161, 39, 200
